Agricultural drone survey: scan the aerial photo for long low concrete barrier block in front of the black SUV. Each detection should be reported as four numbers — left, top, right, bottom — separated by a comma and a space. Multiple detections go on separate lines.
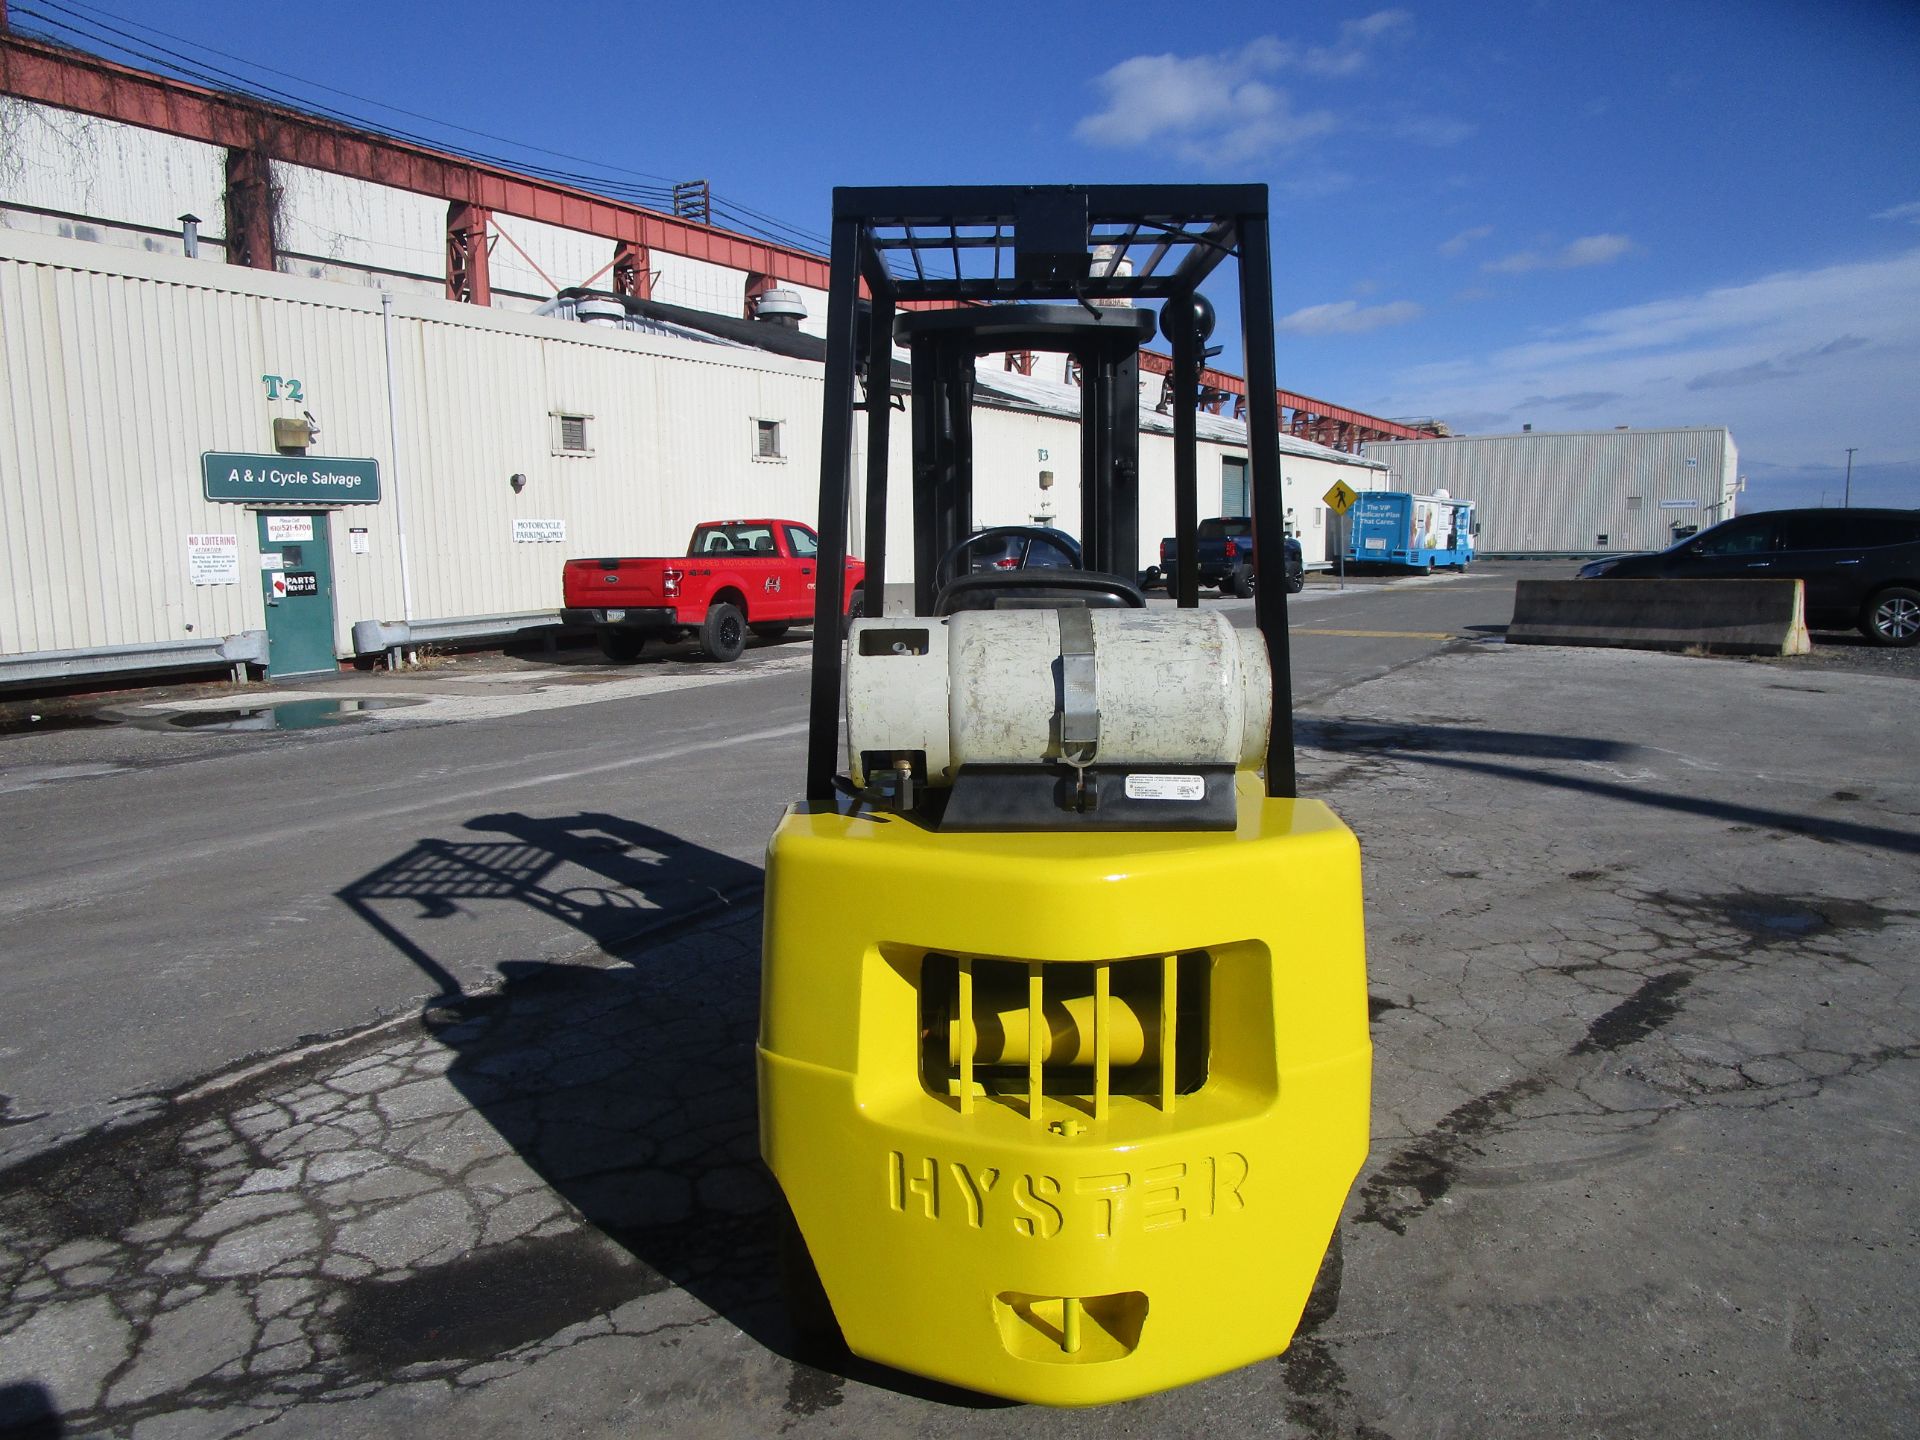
1507, 580, 1812, 655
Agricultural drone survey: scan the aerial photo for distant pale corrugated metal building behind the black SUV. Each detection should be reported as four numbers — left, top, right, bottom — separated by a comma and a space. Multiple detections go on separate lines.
1365, 426, 1740, 555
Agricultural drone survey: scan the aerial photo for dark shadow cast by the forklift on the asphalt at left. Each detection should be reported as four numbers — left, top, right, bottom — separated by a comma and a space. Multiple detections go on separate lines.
338, 812, 1008, 1407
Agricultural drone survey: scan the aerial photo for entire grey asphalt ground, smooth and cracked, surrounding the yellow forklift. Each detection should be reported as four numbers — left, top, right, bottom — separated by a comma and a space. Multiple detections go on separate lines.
0, 574, 1920, 1440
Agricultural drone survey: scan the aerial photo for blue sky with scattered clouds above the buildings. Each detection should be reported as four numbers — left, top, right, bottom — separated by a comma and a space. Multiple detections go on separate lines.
12, 0, 1920, 509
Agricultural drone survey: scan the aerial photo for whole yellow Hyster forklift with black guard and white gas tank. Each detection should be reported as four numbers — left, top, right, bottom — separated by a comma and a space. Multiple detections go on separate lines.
758, 186, 1371, 1405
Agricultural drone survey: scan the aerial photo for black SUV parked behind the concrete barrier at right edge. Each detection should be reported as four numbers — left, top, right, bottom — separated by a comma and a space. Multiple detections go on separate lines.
1580, 509, 1920, 645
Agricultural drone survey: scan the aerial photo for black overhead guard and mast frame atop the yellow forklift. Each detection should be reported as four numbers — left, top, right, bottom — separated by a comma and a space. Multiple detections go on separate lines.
806, 184, 1296, 801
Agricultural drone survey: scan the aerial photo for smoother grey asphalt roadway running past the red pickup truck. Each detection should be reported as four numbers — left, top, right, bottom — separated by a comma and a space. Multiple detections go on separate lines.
0, 576, 1511, 1164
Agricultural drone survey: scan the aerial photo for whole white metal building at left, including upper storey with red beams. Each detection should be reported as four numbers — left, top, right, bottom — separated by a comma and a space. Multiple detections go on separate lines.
0, 53, 1384, 678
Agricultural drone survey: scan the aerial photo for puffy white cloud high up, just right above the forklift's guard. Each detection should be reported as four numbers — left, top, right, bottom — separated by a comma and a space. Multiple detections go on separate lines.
1073, 10, 1413, 165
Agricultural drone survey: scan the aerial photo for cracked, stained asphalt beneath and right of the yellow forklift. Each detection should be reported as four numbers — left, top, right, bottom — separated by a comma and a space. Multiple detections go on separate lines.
0, 645, 1920, 1440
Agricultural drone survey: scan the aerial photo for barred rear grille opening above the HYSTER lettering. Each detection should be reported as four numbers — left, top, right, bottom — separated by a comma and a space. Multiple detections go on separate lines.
920, 950, 1213, 1123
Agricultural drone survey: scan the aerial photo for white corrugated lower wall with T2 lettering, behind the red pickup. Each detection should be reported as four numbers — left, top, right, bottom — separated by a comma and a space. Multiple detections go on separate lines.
0, 228, 1384, 683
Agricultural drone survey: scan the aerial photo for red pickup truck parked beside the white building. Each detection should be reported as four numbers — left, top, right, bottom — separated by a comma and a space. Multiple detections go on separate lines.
561, 520, 866, 662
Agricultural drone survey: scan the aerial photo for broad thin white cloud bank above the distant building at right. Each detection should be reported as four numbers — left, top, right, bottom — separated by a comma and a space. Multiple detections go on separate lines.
1377, 248, 1920, 467
